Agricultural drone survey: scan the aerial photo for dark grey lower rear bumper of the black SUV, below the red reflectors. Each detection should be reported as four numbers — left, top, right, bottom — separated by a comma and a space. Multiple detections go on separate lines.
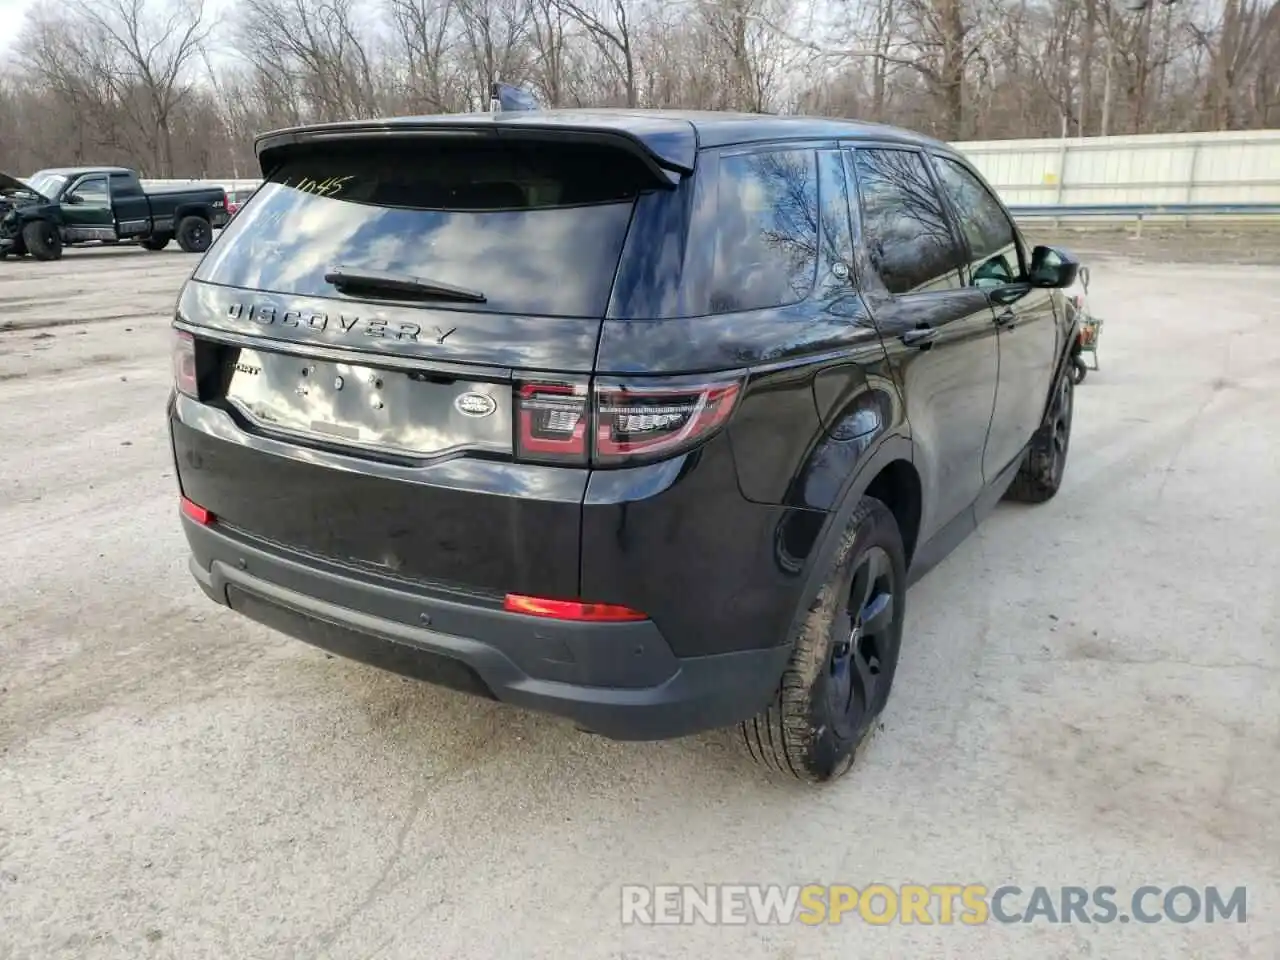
183, 517, 788, 740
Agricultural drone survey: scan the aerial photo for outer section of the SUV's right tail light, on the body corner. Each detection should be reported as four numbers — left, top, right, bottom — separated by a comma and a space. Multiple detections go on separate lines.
593, 380, 741, 466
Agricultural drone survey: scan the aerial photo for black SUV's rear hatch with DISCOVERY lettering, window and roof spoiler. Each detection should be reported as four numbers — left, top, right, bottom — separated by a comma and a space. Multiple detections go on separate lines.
174, 131, 669, 596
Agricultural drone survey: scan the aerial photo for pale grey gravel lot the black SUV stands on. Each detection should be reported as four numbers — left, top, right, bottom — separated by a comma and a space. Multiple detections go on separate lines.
0, 244, 1280, 960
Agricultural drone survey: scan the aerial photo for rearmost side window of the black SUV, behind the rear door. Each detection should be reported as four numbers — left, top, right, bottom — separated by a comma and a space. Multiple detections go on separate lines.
709, 150, 818, 314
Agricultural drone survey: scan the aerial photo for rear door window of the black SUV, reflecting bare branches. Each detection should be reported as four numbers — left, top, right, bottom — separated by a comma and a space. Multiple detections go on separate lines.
854, 150, 960, 293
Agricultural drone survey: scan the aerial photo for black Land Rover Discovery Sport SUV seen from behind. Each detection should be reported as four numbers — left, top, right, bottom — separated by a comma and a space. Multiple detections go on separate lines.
168, 110, 1076, 781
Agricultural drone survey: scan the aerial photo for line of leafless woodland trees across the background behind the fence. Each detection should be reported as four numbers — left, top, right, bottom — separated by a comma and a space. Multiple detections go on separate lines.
0, 0, 1280, 175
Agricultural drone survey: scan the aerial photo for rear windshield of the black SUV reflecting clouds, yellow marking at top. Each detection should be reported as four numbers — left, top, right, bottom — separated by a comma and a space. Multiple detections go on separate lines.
196, 138, 645, 316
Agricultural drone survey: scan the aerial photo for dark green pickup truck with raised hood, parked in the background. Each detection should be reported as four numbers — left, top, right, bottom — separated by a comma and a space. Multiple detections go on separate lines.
0, 166, 228, 260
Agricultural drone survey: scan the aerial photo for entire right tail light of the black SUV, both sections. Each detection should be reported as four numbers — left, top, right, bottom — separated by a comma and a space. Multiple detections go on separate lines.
516, 379, 742, 466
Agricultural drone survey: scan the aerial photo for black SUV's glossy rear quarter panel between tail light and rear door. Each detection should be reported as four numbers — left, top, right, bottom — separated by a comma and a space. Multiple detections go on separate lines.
593, 143, 911, 655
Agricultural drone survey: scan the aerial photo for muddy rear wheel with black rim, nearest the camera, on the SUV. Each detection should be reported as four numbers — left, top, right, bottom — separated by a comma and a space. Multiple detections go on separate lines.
741, 497, 906, 783
